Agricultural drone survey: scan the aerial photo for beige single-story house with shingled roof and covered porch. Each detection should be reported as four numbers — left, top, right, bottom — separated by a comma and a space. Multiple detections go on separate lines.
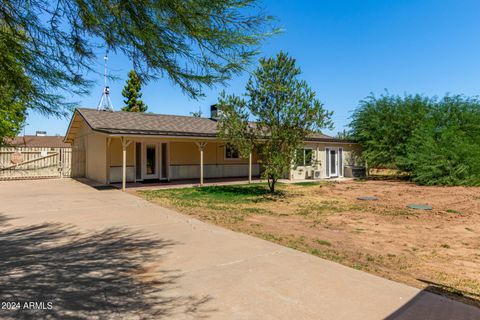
65, 106, 359, 190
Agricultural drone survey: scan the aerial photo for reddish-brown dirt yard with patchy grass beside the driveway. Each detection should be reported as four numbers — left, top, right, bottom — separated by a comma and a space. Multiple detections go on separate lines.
139, 181, 480, 305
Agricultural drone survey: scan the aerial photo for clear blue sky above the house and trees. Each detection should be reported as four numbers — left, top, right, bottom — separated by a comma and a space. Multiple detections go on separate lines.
25, 0, 480, 135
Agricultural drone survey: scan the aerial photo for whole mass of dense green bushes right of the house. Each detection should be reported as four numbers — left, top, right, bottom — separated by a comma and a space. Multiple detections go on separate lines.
350, 93, 480, 185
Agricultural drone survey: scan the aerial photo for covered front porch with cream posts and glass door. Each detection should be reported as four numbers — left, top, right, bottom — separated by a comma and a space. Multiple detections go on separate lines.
106, 136, 260, 191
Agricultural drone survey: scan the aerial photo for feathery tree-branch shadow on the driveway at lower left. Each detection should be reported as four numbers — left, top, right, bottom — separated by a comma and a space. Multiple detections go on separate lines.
0, 214, 214, 319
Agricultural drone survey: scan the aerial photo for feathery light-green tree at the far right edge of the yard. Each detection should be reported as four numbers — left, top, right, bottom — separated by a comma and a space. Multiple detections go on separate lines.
399, 96, 480, 186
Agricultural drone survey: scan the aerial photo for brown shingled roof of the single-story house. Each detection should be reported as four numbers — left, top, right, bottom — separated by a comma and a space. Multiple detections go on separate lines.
77, 108, 348, 141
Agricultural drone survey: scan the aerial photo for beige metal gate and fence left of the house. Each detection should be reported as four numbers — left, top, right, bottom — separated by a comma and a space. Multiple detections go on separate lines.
0, 147, 72, 180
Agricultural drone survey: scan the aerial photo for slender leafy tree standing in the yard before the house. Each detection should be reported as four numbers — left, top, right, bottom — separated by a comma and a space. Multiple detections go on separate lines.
218, 52, 332, 193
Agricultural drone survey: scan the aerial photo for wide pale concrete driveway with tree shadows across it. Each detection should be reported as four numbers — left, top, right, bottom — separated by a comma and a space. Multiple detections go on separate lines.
0, 179, 480, 319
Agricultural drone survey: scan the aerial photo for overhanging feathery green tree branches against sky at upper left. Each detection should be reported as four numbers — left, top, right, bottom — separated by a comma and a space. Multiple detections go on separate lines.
0, 0, 272, 115
